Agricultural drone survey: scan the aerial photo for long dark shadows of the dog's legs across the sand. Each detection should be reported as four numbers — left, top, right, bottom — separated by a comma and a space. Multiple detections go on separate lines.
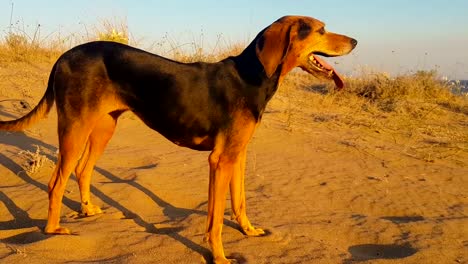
0, 131, 239, 263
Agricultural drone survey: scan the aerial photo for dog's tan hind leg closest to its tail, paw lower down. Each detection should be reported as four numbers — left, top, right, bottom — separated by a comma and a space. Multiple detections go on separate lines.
44, 120, 91, 234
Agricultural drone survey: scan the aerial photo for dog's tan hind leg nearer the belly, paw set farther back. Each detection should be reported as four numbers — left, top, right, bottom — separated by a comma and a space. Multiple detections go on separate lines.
75, 114, 118, 216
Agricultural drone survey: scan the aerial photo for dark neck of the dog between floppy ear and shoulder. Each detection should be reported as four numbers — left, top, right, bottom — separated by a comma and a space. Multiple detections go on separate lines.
228, 39, 282, 119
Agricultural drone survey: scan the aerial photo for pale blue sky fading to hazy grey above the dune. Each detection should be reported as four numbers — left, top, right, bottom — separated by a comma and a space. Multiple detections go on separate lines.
0, 0, 468, 79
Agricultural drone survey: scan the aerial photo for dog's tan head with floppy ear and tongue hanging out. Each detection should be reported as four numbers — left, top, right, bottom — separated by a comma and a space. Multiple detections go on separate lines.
256, 16, 357, 89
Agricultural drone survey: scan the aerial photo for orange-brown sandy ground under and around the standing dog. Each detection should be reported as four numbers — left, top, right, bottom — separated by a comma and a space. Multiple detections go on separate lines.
0, 60, 468, 263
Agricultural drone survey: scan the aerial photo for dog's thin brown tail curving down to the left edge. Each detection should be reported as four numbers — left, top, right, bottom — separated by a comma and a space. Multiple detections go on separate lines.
0, 63, 57, 131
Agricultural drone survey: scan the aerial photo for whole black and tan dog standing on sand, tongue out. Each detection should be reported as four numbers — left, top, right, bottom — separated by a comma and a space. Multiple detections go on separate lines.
0, 16, 357, 263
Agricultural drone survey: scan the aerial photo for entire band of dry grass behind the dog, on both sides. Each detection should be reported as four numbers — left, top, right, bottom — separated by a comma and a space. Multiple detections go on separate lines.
0, 21, 468, 167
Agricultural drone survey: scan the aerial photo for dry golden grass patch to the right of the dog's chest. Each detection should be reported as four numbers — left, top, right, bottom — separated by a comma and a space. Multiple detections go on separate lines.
278, 72, 468, 163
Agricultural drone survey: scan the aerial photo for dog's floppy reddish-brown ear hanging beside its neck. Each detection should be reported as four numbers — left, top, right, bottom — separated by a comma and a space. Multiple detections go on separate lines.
255, 21, 291, 78
